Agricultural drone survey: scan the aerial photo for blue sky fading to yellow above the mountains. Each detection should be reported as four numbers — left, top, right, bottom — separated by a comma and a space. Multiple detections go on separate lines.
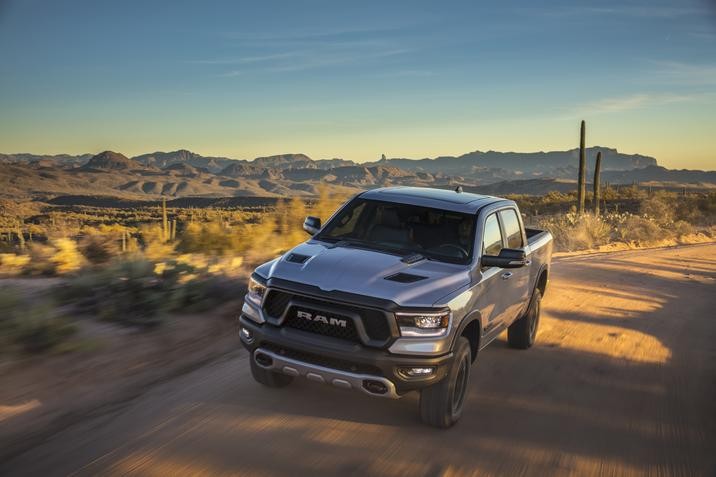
0, 0, 716, 169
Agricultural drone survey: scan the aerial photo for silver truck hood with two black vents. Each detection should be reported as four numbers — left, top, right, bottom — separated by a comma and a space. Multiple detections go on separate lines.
256, 241, 470, 307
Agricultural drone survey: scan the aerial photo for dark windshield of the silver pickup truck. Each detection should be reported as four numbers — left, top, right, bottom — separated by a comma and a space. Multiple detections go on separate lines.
314, 198, 475, 264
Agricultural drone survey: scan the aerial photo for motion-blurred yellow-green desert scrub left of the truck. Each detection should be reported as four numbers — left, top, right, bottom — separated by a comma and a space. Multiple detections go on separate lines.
0, 189, 346, 353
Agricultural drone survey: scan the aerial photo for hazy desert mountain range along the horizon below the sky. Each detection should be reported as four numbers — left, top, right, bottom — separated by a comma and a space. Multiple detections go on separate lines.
0, 147, 716, 200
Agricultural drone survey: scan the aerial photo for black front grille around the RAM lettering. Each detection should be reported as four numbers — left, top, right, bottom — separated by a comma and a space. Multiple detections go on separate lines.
264, 290, 390, 342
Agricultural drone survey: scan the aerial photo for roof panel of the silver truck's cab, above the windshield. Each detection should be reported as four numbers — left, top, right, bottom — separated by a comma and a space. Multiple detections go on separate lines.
360, 186, 507, 214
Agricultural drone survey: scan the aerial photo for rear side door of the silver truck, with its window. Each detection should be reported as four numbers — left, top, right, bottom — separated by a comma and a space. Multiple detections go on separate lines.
498, 208, 531, 325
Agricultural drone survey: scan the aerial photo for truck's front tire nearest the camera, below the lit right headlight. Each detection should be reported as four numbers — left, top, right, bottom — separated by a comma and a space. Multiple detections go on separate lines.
420, 336, 472, 429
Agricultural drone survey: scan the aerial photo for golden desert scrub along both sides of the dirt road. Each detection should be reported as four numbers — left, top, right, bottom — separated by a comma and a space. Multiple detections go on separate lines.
0, 186, 716, 353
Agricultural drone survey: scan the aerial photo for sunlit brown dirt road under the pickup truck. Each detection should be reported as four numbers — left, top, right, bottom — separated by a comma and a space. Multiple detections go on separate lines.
0, 245, 716, 476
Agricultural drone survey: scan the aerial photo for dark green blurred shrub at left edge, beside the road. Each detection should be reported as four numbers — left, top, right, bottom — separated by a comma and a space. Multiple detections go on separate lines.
0, 289, 76, 353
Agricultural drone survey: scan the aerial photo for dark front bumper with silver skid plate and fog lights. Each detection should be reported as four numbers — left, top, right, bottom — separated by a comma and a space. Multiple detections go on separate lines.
239, 315, 453, 398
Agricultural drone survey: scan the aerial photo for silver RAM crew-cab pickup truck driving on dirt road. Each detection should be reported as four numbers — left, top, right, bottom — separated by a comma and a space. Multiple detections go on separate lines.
239, 187, 552, 427
